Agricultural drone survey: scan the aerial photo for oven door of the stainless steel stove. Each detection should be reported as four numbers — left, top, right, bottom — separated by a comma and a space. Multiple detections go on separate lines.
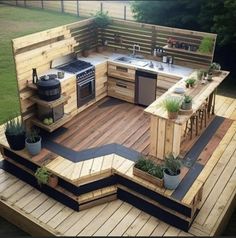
77, 77, 95, 107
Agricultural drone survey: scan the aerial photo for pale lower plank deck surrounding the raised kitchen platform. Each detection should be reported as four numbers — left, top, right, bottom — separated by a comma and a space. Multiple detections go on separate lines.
0, 96, 236, 236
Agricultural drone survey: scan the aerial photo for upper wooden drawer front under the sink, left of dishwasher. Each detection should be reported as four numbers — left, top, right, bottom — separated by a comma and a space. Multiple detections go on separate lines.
108, 62, 136, 82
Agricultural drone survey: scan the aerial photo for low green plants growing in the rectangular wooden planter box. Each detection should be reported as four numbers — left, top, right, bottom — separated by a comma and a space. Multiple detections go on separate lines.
135, 157, 163, 179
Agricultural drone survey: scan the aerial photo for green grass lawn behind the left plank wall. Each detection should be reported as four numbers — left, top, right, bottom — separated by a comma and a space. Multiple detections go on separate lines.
0, 4, 82, 124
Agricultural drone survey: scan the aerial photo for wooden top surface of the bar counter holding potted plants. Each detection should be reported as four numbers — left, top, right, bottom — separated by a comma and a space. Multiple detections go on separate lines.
144, 71, 229, 125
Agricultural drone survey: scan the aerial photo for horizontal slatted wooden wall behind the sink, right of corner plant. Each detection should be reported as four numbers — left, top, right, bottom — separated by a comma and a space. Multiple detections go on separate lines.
102, 19, 216, 68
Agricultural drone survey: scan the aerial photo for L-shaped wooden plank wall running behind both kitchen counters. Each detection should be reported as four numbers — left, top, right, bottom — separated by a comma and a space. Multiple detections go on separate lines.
12, 18, 216, 119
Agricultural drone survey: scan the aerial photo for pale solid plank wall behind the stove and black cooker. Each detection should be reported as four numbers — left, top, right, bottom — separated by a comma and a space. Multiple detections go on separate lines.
12, 19, 93, 120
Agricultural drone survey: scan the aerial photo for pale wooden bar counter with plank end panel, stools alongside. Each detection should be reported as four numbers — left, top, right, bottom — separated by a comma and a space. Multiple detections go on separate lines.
144, 71, 229, 159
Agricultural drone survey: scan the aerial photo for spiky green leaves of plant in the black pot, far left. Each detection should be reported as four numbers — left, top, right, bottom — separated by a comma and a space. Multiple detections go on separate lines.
5, 117, 25, 135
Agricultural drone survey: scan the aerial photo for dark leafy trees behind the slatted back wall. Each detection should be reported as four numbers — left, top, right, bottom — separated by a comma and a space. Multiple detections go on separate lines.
132, 0, 236, 48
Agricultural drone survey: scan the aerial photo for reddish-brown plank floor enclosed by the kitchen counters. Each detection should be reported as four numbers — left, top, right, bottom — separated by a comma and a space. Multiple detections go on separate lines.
56, 98, 150, 152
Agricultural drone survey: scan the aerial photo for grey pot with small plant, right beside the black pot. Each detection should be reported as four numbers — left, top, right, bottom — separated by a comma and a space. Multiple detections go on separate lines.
25, 129, 42, 155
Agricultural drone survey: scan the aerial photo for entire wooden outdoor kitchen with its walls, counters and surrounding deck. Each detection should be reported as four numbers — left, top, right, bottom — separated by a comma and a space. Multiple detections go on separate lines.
0, 9, 236, 236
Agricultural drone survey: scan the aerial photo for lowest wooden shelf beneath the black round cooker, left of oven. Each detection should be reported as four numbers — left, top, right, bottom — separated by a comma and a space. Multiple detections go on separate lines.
31, 114, 72, 132
